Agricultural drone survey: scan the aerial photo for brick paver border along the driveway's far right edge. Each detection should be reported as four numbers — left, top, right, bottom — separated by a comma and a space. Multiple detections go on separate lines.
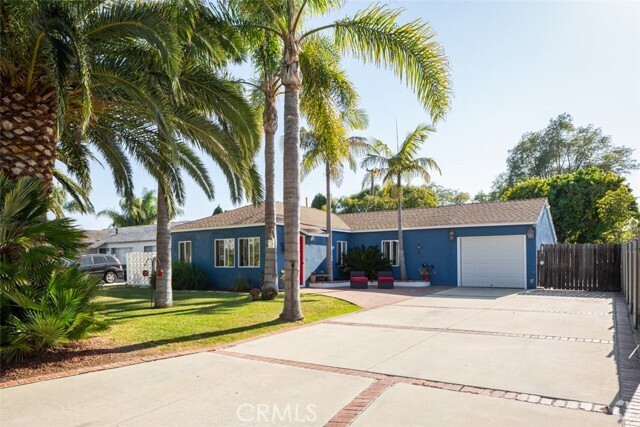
614, 292, 640, 427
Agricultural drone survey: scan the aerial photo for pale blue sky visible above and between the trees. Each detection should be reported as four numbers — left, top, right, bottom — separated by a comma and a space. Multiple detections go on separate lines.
73, 1, 640, 229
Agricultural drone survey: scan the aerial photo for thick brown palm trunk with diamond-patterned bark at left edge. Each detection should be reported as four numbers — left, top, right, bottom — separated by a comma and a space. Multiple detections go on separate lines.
0, 88, 57, 190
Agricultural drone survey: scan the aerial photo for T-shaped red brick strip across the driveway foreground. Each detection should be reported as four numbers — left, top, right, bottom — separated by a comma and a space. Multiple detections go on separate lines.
218, 350, 612, 416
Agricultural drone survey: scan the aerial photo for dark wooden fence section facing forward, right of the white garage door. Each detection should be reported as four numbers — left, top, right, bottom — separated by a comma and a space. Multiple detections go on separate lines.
537, 244, 621, 292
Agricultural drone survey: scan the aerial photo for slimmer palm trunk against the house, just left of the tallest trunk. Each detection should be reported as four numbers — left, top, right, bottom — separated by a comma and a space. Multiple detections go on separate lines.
262, 92, 278, 295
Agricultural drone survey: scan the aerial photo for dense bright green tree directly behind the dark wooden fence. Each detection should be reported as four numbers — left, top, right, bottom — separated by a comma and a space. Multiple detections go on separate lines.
503, 168, 638, 243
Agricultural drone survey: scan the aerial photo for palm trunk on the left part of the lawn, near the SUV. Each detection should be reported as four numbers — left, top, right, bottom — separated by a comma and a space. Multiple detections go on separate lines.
155, 182, 173, 308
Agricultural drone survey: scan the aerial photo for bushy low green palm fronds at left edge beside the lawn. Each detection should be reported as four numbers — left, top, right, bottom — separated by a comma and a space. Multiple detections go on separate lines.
0, 174, 105, 361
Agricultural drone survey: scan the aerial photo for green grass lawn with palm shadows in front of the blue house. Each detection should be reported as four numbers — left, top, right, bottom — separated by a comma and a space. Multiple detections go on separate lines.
95, 287, 360, 354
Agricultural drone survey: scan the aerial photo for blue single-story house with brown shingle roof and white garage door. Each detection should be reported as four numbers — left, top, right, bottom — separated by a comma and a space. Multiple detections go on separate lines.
171, 199, 556, 289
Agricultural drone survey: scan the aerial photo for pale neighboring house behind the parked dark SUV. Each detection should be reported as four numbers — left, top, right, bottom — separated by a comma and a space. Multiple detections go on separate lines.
89, 222, 183, 265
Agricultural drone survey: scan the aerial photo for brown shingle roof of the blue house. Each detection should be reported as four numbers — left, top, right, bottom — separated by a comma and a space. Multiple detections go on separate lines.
175, 198, 547, 231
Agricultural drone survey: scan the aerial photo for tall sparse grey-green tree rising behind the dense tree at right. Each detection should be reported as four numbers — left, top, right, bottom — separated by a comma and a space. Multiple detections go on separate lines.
494, 113, 640, 192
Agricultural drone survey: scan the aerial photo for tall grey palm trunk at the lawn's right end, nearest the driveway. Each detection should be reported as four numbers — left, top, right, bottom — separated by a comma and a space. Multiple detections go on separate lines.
280, 34, 303, 321
